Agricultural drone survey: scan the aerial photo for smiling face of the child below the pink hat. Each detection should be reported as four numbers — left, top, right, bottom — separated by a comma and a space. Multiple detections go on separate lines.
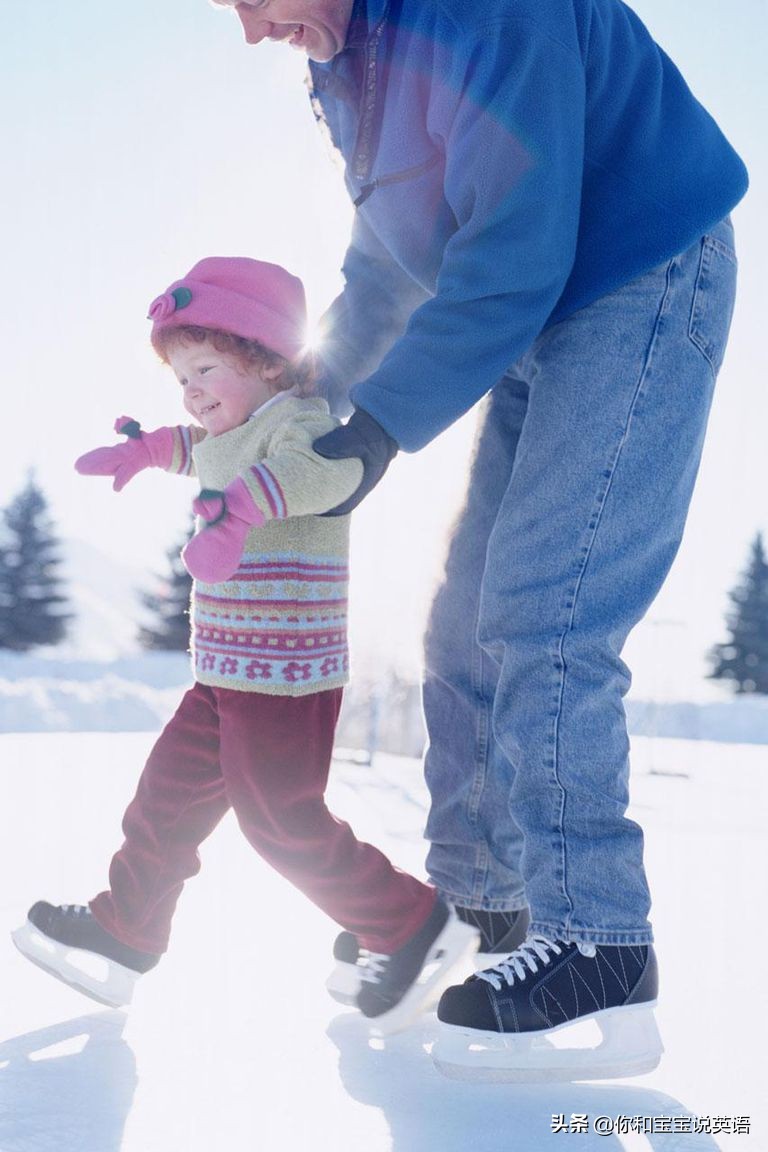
168, 340, 282, 435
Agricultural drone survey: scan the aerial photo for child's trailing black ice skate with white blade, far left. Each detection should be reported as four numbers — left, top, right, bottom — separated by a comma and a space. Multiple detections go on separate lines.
12, 900, 160, 1008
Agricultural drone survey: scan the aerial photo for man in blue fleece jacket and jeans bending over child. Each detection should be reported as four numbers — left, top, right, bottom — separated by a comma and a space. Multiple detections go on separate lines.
218, 0, 746, 1075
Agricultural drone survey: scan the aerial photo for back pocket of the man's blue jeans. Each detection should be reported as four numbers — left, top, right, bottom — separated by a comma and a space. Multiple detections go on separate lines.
689, 235, 737, 376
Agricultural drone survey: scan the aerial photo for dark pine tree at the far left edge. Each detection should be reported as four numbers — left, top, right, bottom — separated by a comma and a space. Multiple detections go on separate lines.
0, 473, 71, 652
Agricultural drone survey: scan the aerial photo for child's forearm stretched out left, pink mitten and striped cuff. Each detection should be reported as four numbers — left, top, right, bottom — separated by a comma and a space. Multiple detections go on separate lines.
75, 416, 206, 492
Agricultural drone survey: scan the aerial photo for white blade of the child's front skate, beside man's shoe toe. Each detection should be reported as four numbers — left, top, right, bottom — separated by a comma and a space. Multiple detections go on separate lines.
368, 916, 479, 1036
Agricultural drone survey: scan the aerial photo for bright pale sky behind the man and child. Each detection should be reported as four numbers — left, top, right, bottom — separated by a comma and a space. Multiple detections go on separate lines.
0, 0, 768, 674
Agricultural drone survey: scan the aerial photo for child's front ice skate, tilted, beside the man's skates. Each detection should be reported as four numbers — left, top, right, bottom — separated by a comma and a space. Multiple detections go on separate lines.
356, 899, 478, 1036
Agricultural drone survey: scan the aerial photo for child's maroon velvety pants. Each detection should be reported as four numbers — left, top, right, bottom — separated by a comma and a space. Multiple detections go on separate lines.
91, 684, 435, 953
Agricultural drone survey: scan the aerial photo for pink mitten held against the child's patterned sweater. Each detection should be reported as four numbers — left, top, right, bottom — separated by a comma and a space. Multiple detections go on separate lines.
182, 477, 265, 584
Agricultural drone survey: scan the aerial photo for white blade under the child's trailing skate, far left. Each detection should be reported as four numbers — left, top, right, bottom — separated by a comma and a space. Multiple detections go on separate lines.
10, 920, 140, 1008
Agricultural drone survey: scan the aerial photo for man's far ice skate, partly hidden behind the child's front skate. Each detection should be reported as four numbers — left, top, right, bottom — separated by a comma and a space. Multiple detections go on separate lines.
326, 905, 531, 1005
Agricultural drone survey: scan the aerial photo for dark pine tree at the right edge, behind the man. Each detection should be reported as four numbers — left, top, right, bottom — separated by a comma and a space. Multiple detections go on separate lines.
709, 532, 768, 695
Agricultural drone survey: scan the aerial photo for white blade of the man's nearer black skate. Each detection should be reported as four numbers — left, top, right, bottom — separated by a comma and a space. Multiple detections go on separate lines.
432, 1001, 664, 1084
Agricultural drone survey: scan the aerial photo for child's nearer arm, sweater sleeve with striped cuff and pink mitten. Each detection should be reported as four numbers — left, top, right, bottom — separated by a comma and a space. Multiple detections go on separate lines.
182, 412, 363, 584
